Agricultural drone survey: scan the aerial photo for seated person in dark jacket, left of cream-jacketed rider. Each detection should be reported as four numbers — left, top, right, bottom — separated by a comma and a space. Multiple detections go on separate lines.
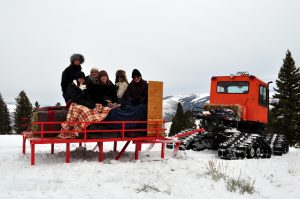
98, 70, 118, 107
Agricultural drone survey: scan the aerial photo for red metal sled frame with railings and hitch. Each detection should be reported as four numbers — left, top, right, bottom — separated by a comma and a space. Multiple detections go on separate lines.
22, 121, 203, 165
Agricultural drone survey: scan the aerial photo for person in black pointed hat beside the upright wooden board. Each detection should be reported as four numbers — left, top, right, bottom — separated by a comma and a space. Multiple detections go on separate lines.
125, 69, 148, 106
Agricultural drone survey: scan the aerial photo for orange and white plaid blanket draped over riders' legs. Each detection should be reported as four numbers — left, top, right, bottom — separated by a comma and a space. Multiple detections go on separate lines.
58, 102, 111, 138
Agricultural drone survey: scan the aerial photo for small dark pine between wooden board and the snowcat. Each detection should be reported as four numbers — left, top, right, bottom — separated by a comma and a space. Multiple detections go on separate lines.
169, 102, 185, 136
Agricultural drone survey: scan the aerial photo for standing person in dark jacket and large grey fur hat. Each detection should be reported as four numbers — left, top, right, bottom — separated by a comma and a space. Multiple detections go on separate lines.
60, 54, 84, 103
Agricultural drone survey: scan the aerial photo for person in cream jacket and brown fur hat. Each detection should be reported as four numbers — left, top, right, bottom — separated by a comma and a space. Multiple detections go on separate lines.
115, 70, 128, 104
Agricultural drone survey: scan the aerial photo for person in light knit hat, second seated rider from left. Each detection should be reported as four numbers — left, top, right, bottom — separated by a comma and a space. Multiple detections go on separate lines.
86, 67, 100, 102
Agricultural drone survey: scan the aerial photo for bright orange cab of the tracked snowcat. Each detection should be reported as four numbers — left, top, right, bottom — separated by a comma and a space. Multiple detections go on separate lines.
208, 72, 269, 125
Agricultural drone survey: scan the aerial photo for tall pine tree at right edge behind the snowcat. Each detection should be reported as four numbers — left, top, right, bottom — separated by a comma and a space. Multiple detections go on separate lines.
271, 50, 300, 145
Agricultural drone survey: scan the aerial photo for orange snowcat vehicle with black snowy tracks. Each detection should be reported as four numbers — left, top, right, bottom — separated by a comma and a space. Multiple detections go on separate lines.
180, 72, 289, 159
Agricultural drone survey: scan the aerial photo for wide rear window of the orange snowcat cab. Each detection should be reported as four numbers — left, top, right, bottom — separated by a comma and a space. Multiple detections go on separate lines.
217, 81, 249, 94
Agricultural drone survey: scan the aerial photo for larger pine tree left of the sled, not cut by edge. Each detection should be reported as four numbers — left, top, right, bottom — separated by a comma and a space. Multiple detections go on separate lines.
14, 91, 32, 134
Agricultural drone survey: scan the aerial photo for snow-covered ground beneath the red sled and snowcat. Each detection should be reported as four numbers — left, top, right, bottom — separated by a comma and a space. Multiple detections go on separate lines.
0, 135, 300, 199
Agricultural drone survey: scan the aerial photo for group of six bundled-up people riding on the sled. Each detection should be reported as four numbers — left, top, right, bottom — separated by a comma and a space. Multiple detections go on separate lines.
61, 54, 148, 109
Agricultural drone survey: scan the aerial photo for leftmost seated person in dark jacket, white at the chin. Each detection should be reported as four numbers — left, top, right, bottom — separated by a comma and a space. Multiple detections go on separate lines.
67, 71, 96, 109
